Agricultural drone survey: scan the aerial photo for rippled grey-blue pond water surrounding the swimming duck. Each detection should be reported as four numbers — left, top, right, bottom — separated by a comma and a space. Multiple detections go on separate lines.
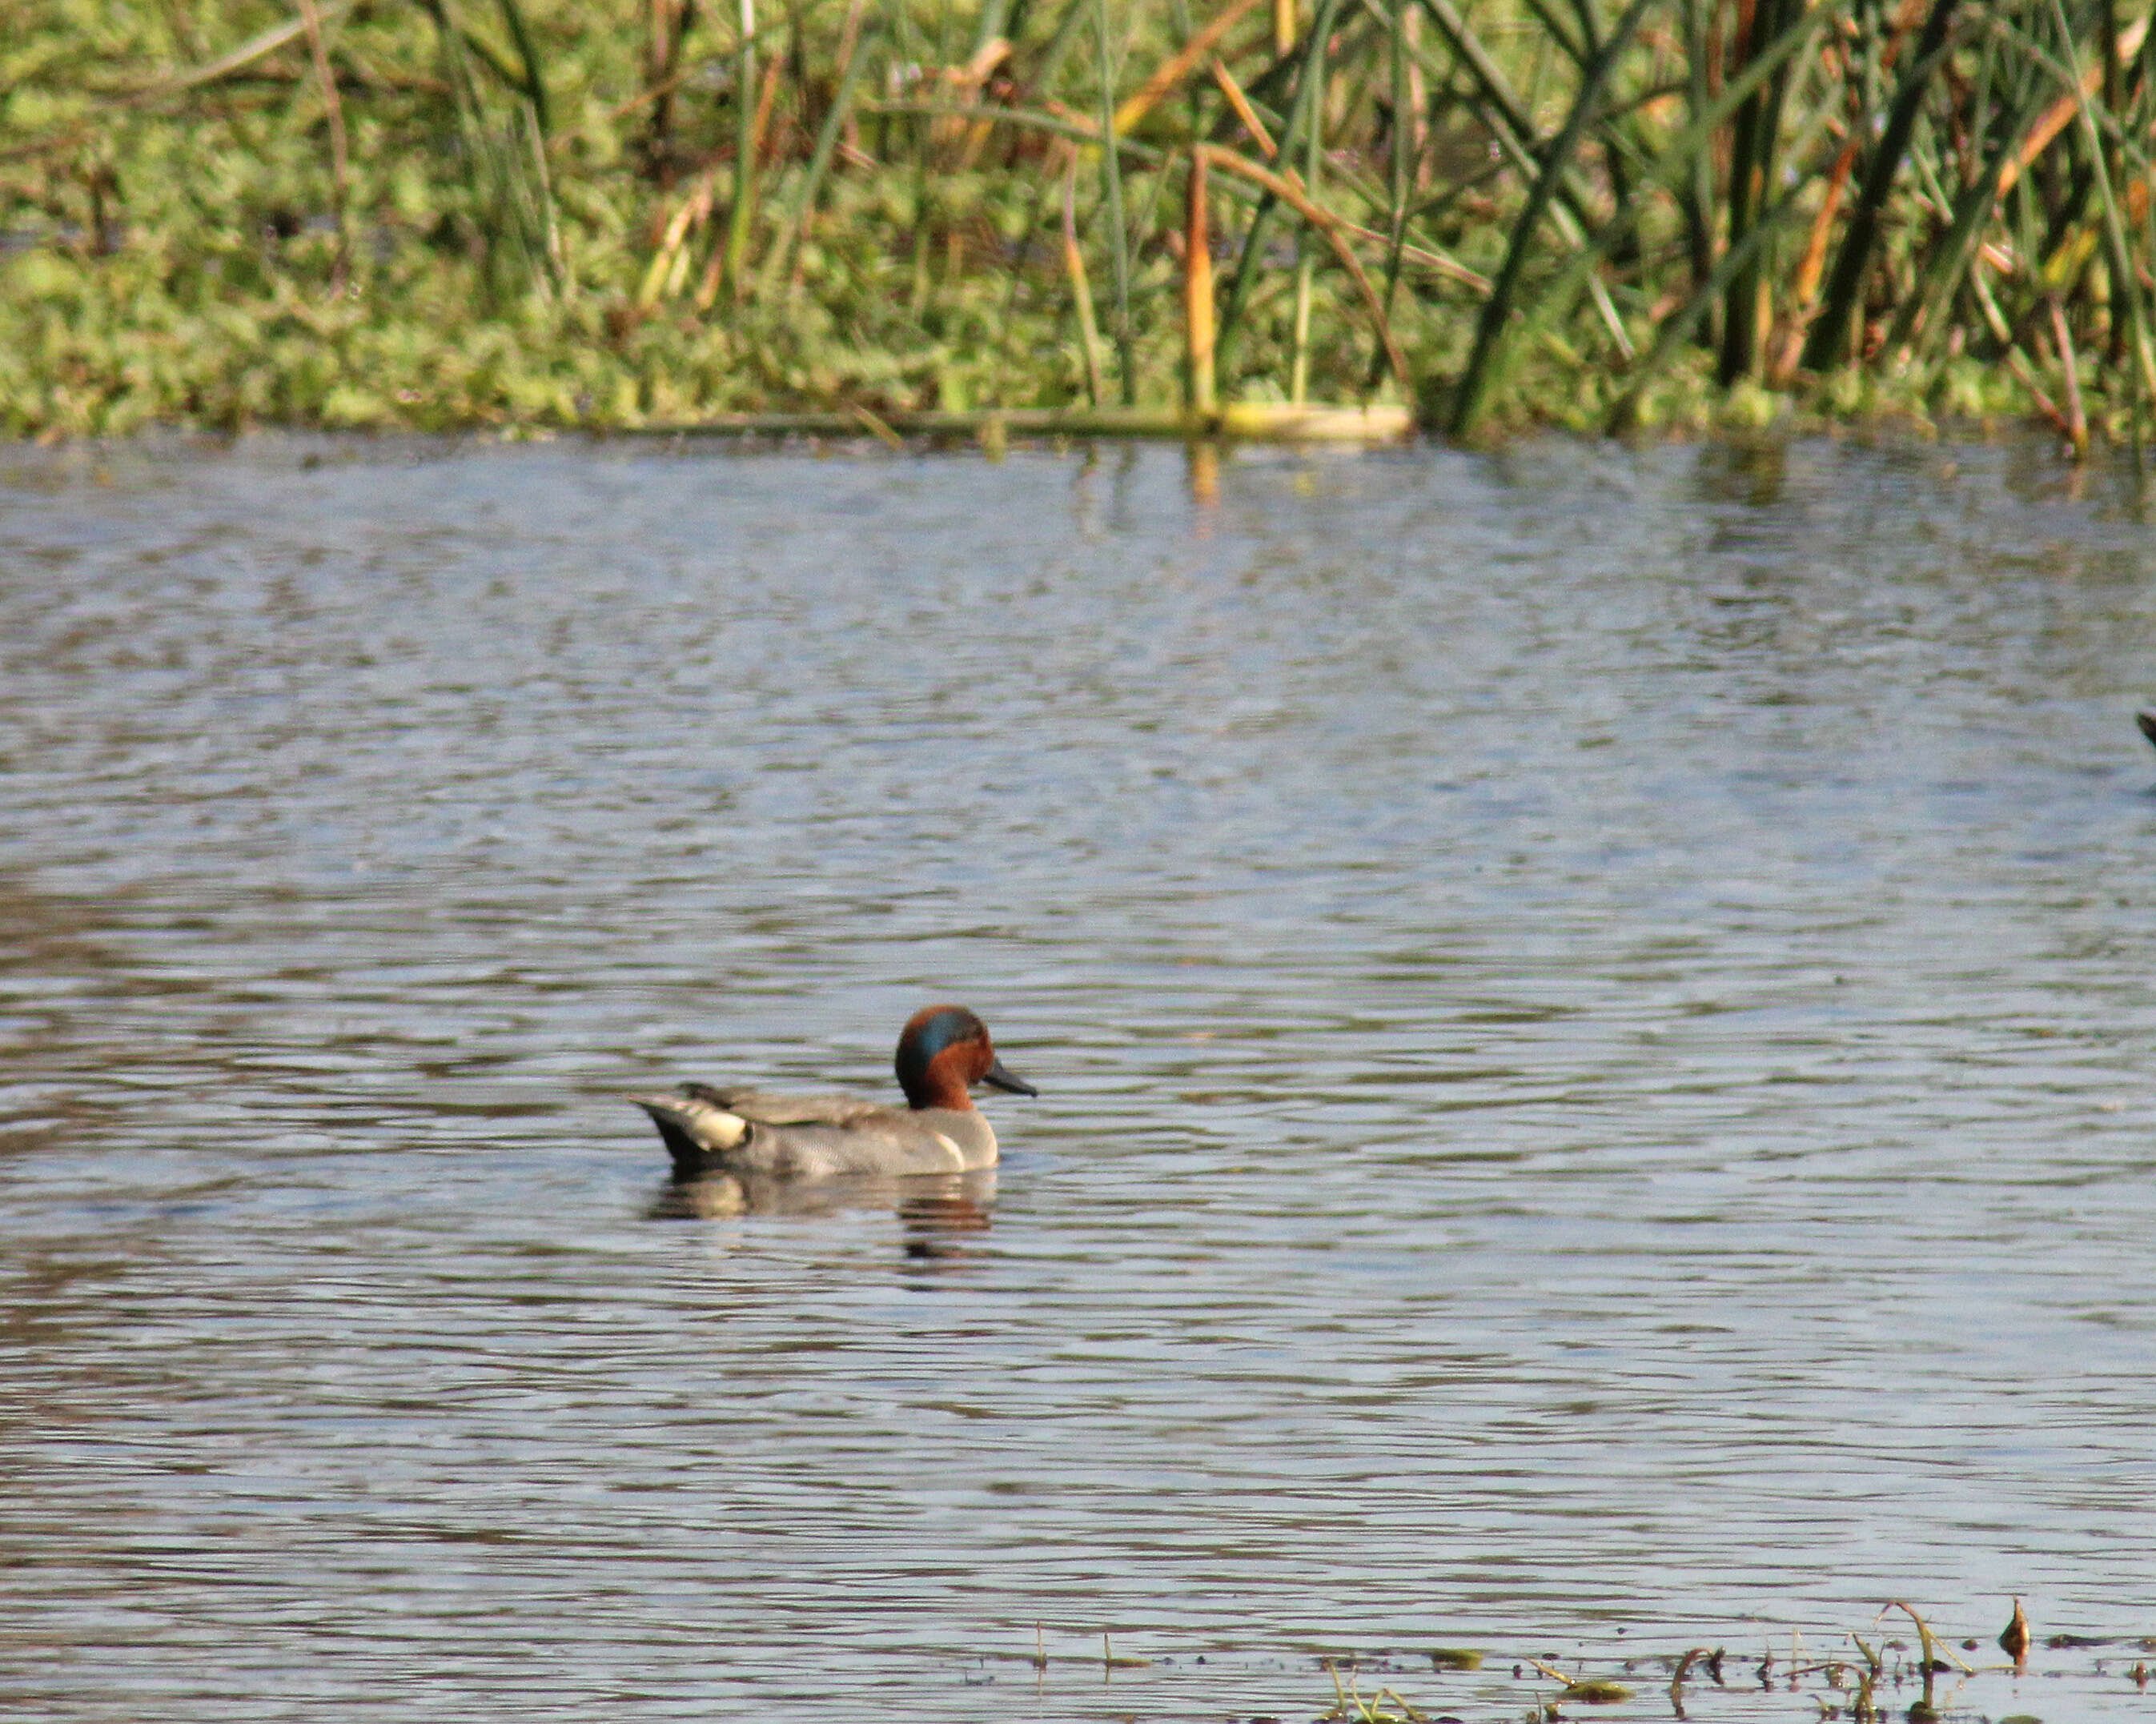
0, 438, 2156, 1720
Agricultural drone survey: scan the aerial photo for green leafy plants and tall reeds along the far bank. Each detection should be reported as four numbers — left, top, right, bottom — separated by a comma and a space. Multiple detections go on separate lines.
12, 0, 2156, 455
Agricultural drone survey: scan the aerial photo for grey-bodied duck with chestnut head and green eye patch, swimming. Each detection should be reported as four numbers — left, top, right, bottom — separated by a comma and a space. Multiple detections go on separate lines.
629, 1006, 1039, 1181
